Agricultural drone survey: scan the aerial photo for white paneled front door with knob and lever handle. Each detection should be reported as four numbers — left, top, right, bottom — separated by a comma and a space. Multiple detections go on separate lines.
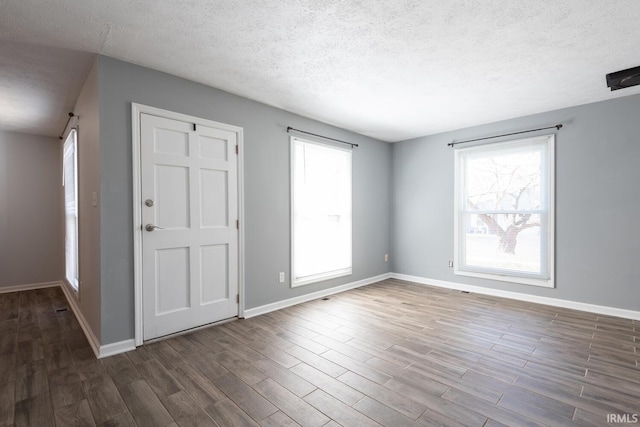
140, 113, 239, 340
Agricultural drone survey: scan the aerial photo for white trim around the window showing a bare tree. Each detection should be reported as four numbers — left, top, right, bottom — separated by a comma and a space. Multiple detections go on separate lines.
453, 134, 555, 288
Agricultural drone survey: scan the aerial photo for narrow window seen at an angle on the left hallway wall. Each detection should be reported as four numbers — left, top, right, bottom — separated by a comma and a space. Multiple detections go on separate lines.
62, 129, 79, 291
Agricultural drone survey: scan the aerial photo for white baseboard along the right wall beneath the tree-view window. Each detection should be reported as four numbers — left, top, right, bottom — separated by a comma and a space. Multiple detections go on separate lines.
391, 273, 640, 320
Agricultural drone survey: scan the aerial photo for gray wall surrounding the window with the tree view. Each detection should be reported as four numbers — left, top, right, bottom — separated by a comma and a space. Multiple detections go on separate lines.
392, 95, 640, 310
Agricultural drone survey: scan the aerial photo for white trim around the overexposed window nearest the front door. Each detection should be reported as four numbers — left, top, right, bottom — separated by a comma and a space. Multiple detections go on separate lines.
289, 136, 353, 288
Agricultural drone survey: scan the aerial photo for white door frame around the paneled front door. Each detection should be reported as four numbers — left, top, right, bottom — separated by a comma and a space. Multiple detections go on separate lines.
131, 102, 244, 347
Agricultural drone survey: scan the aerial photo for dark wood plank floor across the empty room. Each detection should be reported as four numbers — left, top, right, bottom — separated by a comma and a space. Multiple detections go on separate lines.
0, 280, 640, 427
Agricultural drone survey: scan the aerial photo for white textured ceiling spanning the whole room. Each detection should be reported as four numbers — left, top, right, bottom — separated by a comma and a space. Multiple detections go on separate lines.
0, 0, 640, 141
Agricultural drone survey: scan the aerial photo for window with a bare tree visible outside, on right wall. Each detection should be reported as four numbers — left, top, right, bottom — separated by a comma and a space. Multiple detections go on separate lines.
455, 135, 554, 287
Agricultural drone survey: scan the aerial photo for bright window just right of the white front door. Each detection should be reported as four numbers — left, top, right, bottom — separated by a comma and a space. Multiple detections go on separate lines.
291, 137, 351, 286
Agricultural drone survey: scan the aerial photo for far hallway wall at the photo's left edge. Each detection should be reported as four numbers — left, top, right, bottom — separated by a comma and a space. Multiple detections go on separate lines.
0, 132, 64, 291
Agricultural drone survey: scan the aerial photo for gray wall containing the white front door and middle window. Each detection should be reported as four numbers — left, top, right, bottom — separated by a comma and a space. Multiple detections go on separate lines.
98, 57, 391, 345
